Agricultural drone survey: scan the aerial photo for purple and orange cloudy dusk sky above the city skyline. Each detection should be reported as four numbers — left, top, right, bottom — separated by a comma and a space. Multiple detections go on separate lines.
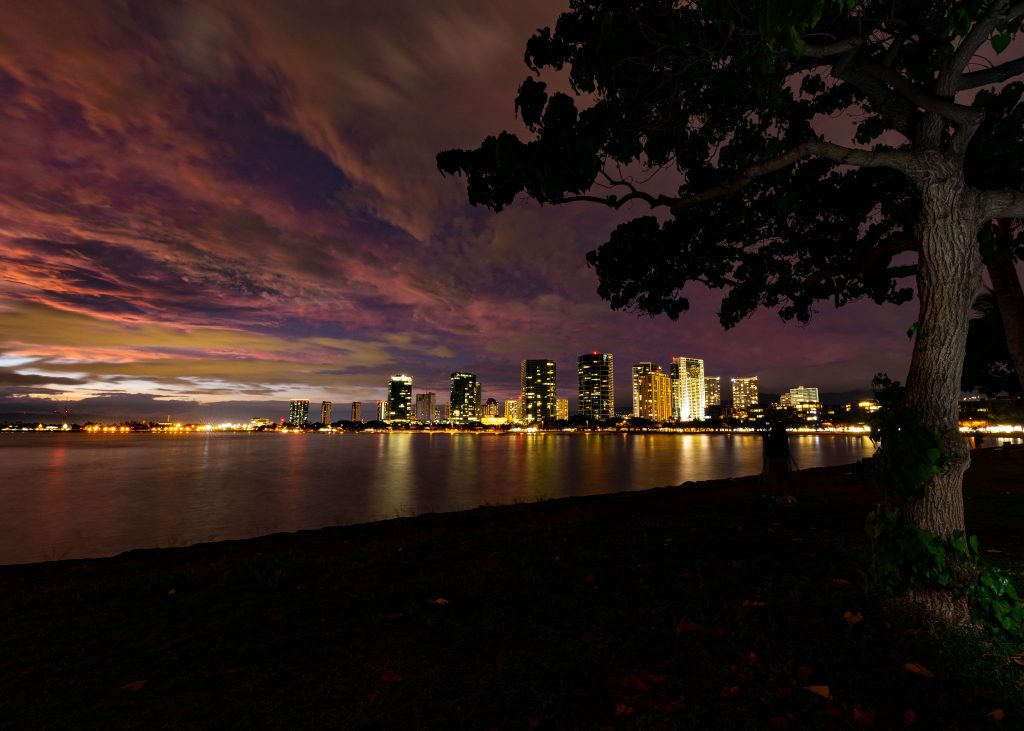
0, 0, 916, 421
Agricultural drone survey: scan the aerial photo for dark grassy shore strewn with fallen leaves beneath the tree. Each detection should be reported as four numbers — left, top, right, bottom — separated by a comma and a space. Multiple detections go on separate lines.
0, 448, 1024, 729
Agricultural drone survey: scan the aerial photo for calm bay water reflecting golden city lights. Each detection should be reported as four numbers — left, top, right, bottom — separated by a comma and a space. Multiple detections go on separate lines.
0, 433, 873, 564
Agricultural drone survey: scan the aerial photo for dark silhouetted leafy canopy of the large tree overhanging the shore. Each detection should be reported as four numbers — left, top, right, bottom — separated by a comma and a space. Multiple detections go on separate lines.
437, 0, 1024, 327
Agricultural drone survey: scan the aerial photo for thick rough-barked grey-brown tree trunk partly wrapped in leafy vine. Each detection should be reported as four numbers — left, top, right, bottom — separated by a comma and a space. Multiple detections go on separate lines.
906, 168, 982, 624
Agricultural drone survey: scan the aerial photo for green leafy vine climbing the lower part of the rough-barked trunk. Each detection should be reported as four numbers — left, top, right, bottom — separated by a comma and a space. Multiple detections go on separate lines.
867, 374, 1024, 638
